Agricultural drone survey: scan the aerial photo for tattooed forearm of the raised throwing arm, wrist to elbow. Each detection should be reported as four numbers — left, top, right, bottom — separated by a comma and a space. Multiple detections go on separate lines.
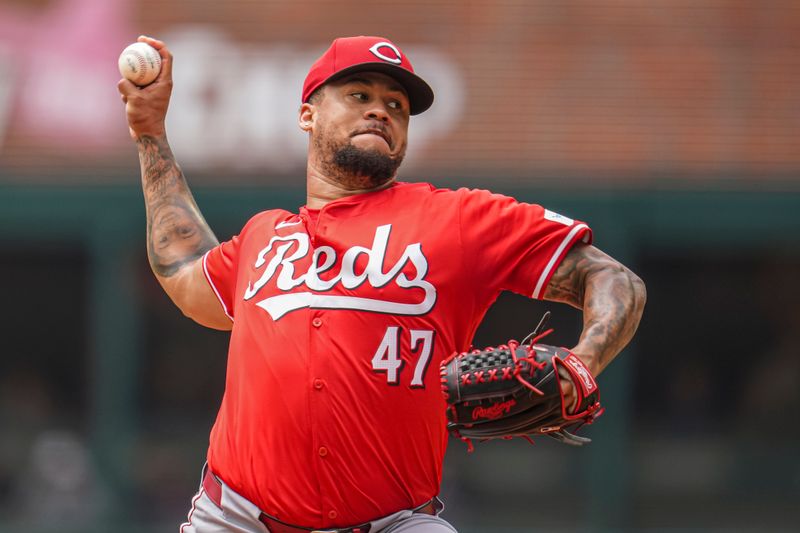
137, 136, 218, 277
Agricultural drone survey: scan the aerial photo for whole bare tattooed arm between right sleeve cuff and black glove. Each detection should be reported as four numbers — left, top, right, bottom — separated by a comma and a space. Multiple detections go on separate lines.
544, 245, 646, 373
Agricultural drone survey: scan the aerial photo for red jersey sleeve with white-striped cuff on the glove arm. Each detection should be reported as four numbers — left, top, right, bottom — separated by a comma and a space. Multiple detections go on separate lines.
459, 189, 592, 299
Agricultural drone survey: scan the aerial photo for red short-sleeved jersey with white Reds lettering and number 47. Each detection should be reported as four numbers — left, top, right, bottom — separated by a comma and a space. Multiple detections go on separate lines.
203, 183, 591, 528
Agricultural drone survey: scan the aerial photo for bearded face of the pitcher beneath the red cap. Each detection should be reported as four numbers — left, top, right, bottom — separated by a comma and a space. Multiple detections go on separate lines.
304, 72, 409, 188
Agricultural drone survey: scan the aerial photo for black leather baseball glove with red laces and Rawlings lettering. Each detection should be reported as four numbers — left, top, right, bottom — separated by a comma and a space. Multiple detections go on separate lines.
440, 312, 603, 451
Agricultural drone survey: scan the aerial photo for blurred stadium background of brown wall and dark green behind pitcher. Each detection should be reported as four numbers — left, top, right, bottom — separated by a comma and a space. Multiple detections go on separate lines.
0, 0, 800, 533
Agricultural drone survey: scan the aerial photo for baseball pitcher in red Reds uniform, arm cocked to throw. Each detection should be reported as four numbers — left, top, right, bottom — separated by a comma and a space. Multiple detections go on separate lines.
118, 36, 645, 533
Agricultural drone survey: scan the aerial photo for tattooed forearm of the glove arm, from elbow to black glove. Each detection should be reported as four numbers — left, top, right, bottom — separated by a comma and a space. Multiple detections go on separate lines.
573, 263, 646, 375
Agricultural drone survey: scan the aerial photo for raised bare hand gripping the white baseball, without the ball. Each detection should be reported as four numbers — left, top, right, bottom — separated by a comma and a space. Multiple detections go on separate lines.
117, 35, 172, 140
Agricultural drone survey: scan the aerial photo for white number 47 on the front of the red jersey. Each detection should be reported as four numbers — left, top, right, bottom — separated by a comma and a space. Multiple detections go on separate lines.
372, 326, 433, 388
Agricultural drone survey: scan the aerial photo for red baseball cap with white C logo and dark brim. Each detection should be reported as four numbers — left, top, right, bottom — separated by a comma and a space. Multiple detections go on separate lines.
303, 35, 433, 115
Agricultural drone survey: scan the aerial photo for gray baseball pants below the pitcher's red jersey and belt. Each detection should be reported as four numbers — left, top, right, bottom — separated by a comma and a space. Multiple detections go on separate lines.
180, 468, 457, 533
